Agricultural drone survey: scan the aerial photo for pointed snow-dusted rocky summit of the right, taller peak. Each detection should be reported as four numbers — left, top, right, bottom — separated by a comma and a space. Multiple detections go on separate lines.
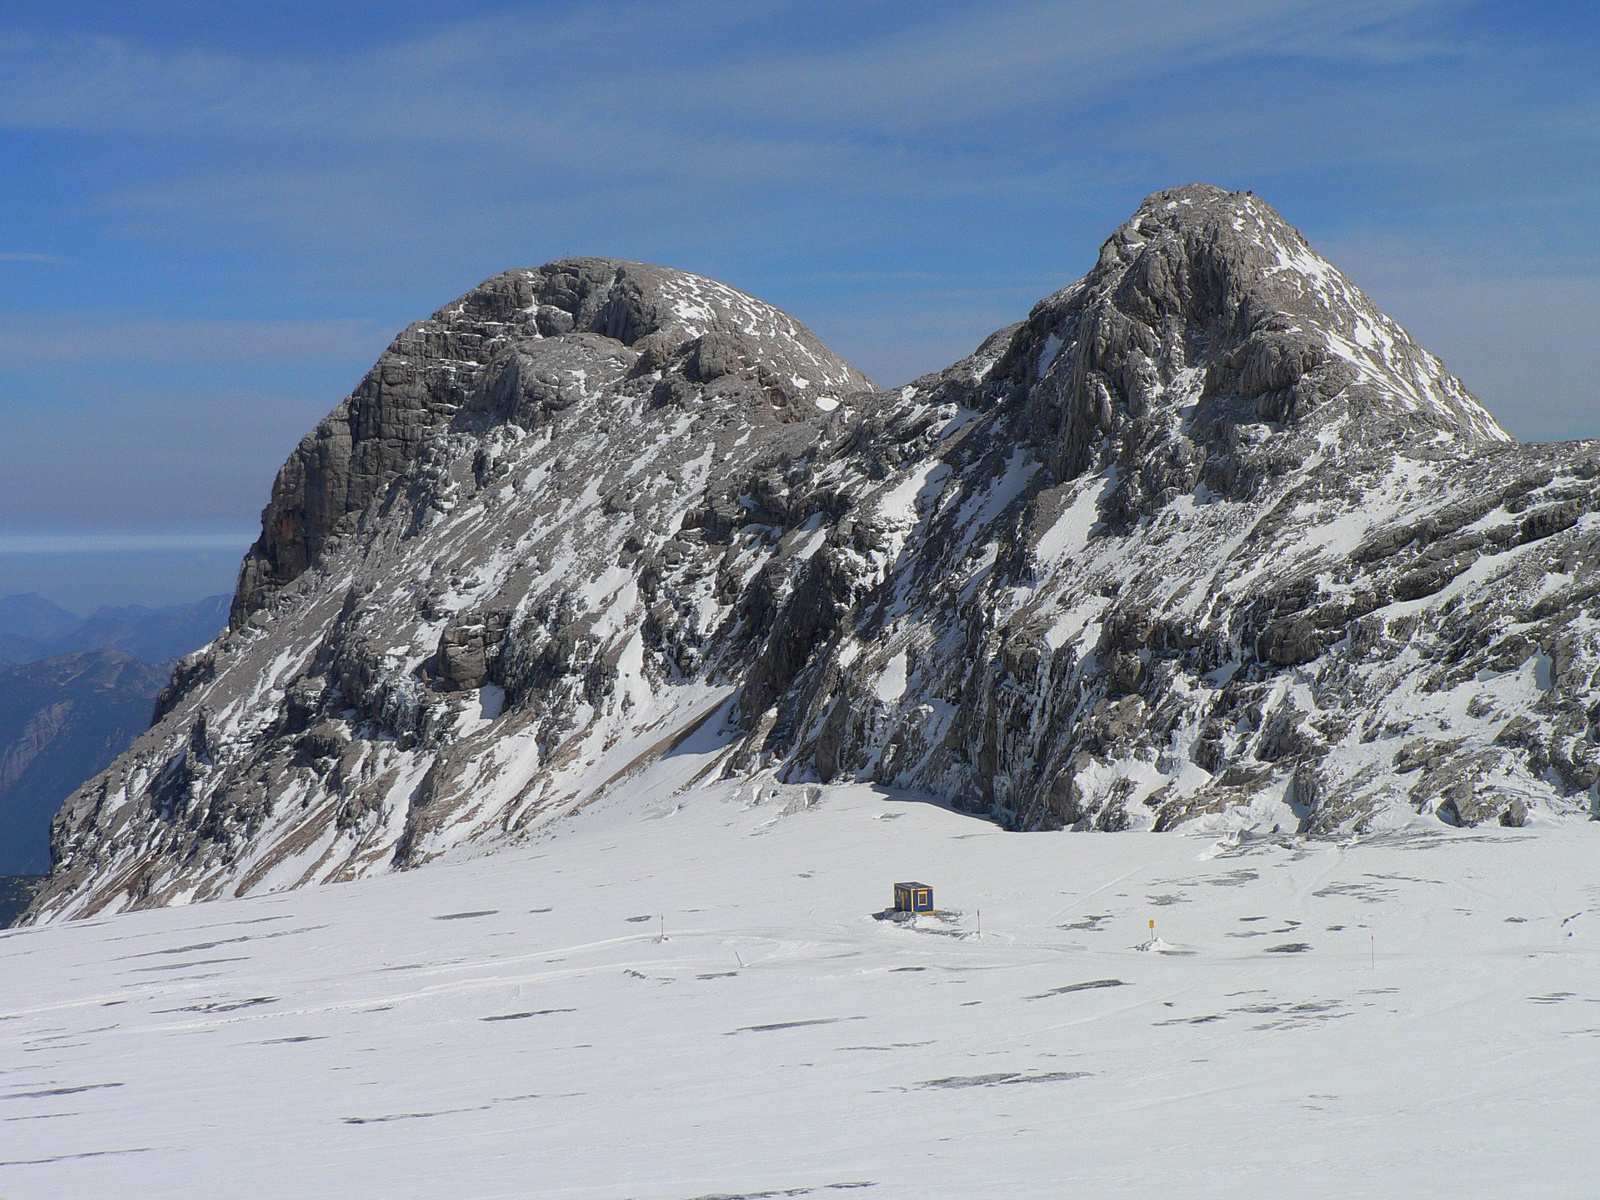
997, 184, 1512, 518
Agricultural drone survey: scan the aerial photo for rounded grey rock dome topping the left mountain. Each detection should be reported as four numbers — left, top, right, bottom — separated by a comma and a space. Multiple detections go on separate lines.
232, 258, 872, 626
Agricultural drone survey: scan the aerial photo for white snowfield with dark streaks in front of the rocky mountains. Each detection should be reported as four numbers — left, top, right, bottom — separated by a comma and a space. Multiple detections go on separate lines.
9, 731, 1600, 1200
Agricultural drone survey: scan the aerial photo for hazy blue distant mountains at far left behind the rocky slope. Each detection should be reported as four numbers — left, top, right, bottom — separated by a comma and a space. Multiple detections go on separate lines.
0, 595, 229, 876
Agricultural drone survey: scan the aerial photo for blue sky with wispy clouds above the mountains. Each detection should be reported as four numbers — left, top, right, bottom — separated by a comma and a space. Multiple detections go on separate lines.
0, 0, 1600, 608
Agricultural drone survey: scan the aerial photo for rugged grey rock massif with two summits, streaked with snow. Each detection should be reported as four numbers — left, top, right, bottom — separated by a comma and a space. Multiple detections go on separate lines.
34, 186, 1600, 917
